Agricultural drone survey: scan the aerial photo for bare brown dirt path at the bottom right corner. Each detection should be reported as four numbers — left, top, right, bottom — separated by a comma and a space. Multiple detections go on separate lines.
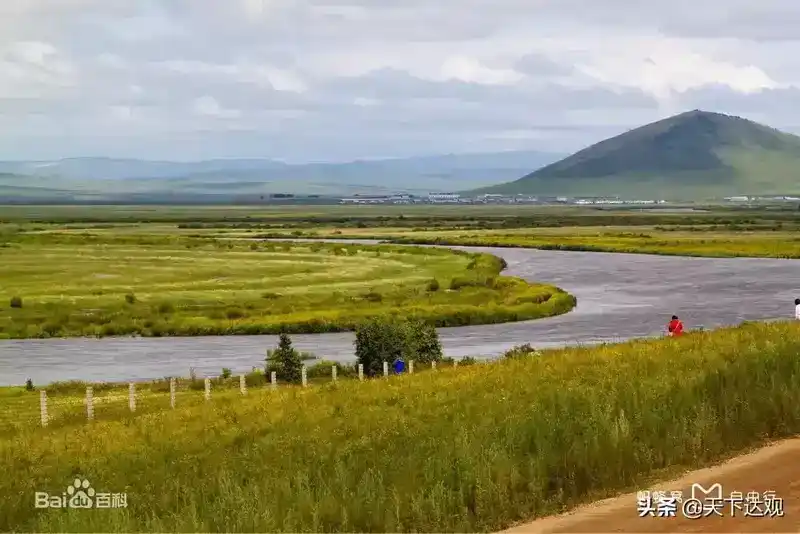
504, 438, 800, 534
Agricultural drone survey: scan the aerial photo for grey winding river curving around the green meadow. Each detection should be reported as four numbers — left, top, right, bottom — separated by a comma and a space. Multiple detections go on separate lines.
0, 247, 800, 385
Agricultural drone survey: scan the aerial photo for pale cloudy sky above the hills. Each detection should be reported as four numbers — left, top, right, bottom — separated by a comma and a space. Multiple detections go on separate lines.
0, 0, 800, 162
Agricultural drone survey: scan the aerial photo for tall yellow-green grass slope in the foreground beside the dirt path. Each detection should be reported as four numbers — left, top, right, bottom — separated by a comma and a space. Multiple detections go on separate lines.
0, 323, 800, 532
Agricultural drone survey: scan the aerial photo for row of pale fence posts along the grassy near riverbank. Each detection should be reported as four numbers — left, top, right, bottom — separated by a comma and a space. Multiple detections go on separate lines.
0, 360, 468, 435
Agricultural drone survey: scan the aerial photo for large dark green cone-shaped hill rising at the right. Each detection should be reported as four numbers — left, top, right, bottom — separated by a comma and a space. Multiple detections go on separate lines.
475, 110, 800, 199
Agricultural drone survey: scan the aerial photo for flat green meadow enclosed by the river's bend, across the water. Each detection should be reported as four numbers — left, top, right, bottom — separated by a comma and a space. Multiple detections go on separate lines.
0, 233, 575, 338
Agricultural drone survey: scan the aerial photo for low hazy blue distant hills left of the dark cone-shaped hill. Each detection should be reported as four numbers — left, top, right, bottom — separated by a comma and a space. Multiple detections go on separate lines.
0, 151, 563, 200
